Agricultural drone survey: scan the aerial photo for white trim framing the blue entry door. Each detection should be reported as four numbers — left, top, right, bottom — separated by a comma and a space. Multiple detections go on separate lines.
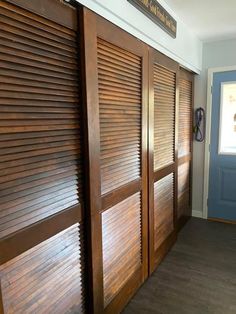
203, 65, 236, 219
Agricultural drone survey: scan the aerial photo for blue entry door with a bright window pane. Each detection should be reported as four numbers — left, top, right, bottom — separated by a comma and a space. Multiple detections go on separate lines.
208, 71, 236, 222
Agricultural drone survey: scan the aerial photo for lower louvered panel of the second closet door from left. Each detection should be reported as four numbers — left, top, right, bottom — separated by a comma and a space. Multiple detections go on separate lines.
102, 193, 142, 306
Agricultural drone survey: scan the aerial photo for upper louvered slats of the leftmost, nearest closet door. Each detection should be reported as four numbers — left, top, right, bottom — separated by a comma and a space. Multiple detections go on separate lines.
0, 4, 81, 237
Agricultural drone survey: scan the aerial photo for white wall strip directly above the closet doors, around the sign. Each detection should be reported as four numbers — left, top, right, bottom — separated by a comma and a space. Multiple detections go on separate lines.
74, 0, 202, 73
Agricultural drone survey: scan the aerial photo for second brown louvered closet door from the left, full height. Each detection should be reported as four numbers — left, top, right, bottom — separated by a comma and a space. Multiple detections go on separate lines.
81, 9, 148, 313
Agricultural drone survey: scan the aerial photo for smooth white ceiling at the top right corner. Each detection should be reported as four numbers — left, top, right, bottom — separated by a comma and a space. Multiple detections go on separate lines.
165, 0, 236, 41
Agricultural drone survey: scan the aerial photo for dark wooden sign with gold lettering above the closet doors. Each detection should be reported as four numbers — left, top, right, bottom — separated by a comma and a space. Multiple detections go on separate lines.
128, 0, 177, 38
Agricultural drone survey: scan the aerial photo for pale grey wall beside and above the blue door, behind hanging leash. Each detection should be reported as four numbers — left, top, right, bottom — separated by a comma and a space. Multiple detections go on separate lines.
193, 39, 236, 216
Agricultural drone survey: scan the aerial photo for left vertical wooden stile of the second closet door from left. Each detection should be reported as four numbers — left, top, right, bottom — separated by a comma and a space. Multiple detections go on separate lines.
81, 8, 104, 314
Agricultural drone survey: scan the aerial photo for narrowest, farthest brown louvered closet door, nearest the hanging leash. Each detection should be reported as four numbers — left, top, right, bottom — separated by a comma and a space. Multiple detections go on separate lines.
177, 69, 194, 228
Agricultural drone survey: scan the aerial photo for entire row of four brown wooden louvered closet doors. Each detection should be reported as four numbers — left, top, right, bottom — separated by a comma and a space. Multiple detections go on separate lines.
0, 0, 193, 314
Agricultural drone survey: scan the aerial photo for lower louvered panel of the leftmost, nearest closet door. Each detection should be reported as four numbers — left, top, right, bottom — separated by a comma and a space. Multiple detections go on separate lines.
0, 224, 84, 313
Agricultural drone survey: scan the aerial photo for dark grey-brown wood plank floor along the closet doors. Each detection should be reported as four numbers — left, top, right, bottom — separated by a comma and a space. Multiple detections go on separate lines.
123, 218, 236, 314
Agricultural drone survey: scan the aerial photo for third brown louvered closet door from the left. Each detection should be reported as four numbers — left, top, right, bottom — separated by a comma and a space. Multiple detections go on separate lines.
149, 49, 178, 272
